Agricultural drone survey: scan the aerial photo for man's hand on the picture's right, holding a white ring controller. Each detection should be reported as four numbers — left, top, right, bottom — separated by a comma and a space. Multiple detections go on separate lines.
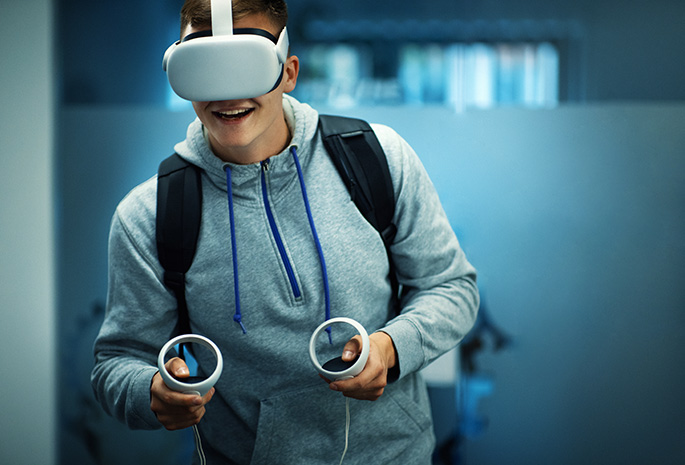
322, 332, 397, 401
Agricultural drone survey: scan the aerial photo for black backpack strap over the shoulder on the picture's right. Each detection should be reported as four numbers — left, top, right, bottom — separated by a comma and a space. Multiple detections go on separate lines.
319, 115, 399, 296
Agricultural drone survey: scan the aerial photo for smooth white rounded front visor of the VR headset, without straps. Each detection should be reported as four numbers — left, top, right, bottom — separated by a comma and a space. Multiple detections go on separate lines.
166, 34, 283, 102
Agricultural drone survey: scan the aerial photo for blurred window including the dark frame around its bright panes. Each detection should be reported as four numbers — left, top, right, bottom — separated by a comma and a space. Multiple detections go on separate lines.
291, 18, 578, 110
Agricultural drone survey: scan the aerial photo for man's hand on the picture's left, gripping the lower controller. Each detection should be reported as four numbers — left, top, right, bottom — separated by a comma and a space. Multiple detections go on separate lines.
150, 357, 214, 431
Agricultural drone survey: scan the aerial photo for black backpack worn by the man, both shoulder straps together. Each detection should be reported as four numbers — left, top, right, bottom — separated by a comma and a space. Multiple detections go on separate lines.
156, 115, 399, 334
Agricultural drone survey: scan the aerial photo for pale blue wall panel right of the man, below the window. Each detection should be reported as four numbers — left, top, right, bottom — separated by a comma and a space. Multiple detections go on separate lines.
352, 105, 685, 464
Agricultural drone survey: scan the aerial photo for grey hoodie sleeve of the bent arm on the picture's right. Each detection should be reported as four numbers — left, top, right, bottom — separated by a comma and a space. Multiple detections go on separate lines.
374, 125, 479, 377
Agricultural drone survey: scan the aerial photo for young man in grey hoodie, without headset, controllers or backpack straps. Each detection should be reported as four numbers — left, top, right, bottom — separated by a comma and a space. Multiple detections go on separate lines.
92, 0, 478, 464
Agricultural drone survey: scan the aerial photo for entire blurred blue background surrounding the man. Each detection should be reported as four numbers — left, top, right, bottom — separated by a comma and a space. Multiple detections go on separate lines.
0, 0, 685, 465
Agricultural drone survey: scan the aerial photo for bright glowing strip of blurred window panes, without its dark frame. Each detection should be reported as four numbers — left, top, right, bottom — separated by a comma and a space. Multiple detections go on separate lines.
293, 42, 559, 110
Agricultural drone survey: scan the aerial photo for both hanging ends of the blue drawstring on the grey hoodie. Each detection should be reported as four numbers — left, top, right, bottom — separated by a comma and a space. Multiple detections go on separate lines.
224, 146, 332, 343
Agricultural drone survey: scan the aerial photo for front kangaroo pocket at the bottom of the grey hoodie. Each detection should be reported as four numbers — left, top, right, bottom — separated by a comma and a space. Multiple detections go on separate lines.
250, 378, 434, 465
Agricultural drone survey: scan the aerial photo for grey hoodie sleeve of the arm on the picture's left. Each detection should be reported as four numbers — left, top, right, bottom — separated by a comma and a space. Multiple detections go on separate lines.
91, 179, 176, 429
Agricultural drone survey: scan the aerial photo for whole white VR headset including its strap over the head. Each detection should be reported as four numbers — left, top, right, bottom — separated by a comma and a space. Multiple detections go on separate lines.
162, 0, 289, 102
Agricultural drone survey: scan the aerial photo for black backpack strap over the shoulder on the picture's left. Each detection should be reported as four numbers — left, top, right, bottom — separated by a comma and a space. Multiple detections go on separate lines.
156, 154, 202, 334
